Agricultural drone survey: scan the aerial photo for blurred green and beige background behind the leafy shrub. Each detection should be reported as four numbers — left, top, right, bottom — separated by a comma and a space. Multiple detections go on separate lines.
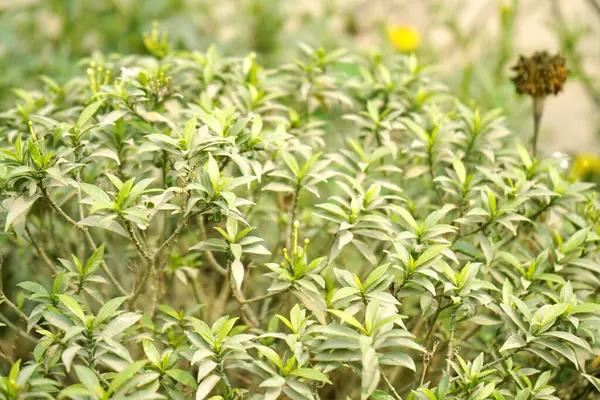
0, 0, 600, 172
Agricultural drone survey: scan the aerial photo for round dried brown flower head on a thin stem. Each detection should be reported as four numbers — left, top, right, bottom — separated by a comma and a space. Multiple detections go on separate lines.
512, 51, 569, 98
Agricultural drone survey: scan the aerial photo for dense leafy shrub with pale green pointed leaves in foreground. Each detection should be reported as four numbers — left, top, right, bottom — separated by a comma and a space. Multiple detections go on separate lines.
0, 43, 600, 400
